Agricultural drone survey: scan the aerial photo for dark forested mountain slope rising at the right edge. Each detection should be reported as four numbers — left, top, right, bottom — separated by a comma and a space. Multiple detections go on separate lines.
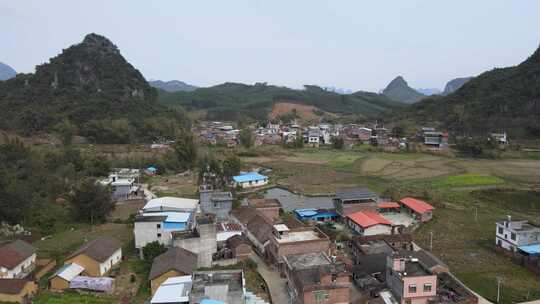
395, 48, 540, 137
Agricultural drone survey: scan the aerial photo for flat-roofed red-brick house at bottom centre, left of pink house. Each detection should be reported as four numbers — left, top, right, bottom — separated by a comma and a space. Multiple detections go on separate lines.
283, 252, 350, 304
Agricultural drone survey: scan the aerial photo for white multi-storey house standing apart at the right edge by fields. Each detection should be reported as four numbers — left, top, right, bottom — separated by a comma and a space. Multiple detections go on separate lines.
495, 216, 540, 252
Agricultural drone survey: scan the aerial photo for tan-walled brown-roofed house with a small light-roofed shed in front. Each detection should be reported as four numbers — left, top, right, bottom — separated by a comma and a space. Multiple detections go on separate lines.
64, 237, 122, 277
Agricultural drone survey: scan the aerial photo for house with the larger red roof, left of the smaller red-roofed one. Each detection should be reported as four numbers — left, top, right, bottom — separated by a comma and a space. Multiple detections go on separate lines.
346, 211, 392, 235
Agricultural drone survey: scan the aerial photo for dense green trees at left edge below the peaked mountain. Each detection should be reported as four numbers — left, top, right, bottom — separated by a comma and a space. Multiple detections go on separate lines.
0, 138, 114, 233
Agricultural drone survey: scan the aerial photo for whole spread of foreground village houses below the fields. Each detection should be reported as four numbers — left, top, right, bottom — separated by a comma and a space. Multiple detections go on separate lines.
0, 154, 540, 304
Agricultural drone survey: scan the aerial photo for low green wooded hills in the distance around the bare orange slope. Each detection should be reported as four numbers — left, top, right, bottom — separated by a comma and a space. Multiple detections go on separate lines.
159, 83, 402, 120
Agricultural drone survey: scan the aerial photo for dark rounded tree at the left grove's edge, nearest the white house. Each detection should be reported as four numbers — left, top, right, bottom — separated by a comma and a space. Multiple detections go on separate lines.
70, 178, 114, 223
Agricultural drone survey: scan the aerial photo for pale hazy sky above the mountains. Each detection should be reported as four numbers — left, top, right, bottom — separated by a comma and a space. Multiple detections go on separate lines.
0, 0, 540, 91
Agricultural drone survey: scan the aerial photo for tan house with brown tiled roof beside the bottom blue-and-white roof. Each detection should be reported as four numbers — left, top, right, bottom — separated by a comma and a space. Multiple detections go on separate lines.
148, 247, 197, 295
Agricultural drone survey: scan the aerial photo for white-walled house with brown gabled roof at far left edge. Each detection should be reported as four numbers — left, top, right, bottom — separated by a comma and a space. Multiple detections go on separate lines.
0, 240, 36, 279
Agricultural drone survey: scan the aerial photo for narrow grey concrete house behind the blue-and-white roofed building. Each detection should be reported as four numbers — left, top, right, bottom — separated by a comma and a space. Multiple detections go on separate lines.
199, 185, 233, 220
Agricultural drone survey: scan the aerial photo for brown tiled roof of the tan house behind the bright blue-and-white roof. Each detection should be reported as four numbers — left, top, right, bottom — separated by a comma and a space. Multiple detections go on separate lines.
148, 247, 197, 280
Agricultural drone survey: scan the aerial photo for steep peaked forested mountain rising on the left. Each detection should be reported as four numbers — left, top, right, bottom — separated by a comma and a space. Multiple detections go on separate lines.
0, 34, 163, 135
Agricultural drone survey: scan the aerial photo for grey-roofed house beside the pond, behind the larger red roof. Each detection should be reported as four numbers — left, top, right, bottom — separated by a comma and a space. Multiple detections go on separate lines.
333, 188, 379, 219
